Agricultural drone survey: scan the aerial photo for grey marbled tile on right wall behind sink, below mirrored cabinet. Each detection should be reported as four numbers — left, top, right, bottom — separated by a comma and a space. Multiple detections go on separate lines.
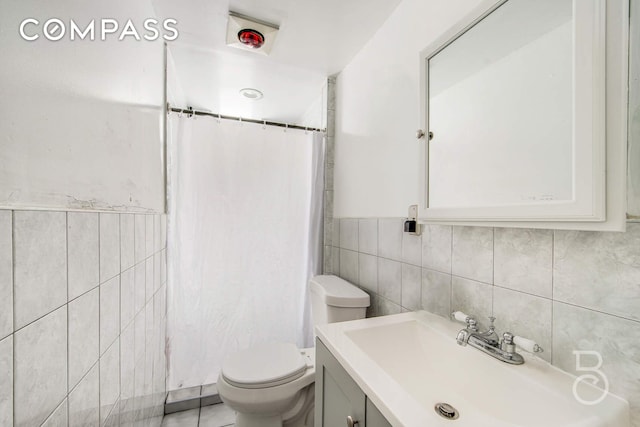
324, 218, 640, 427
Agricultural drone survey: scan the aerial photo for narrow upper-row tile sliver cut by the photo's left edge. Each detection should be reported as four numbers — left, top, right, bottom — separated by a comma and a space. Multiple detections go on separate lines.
0, 210, 13, 340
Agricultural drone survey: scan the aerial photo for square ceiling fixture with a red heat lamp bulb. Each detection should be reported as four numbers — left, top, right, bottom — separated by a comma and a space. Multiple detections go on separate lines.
227, 12, 279, 55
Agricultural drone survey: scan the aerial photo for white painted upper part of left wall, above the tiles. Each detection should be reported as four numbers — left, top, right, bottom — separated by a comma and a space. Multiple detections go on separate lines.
0, 0, 164, 212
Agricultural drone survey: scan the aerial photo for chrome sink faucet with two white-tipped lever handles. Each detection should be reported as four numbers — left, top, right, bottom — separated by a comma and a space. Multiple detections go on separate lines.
451, 311, 543, 365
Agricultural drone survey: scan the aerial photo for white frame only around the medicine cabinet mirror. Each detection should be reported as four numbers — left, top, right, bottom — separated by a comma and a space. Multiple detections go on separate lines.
419, 0, 607, 223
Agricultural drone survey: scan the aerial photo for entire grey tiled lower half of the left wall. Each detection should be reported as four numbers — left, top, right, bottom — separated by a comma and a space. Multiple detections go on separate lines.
0, 210, 166, 427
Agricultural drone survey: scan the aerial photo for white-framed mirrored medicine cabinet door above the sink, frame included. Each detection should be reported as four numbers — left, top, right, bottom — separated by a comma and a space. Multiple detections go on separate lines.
421, 0, 605, 221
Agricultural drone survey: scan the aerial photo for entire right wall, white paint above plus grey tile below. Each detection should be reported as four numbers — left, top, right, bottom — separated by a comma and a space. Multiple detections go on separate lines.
324, 0, 640, 427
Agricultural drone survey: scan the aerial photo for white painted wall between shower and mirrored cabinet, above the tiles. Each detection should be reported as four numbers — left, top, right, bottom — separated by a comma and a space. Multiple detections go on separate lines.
335, 0, 480, 217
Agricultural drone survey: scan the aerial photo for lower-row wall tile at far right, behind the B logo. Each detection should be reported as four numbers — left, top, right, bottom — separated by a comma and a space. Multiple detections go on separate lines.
553, 302, 640, 426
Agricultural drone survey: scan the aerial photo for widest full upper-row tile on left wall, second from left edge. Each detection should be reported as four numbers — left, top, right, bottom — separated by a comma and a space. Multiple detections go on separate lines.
13, 211, 67, 330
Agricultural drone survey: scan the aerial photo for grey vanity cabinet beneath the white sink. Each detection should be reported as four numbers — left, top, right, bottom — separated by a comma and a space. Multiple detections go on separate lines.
315, 339, 391, 427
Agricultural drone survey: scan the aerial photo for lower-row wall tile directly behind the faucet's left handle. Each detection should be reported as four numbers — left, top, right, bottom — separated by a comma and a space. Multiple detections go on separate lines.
451, 276, 493, 329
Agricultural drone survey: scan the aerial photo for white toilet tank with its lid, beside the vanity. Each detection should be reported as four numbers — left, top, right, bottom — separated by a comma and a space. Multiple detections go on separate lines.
309, 275, 370, 326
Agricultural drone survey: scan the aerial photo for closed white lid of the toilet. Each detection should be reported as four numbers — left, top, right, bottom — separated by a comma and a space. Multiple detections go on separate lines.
222, 343, 307, 388
